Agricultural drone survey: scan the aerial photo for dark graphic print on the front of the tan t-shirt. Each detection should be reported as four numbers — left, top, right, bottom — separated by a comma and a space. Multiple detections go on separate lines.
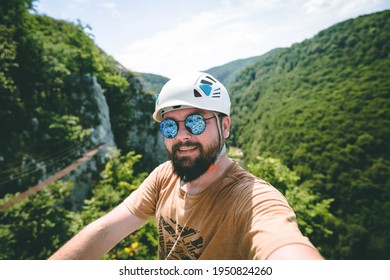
158, 216, 203, 260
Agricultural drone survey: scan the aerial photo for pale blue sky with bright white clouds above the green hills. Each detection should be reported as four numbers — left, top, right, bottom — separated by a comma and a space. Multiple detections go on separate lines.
35, 0, 390, 78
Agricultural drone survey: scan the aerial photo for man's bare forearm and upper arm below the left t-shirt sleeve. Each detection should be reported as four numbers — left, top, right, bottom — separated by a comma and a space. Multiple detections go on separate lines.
49, 203, 145, 260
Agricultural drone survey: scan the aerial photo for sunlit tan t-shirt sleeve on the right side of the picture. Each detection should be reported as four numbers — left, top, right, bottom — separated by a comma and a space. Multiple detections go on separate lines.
240, 182, 315, 259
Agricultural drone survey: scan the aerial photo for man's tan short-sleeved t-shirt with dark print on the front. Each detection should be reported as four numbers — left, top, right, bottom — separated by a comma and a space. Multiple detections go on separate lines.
125, 162, 314, 260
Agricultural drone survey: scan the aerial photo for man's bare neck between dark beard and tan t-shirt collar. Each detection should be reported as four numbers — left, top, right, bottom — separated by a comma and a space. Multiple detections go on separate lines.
182, 154, 233, 194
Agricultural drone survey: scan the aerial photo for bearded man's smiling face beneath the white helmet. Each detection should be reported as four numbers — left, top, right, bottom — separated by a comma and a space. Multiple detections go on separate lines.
164, 108, 220, 182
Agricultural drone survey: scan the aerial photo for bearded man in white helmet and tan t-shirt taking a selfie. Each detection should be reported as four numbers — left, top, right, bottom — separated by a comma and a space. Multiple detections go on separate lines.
50, 73, 323, 259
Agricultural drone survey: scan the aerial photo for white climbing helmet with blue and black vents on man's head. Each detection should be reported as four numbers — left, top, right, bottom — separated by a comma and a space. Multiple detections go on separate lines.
153, 72, 230, 122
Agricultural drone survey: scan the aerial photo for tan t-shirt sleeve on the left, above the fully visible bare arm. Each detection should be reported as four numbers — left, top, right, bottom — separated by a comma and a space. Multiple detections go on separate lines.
124, 164, 166, 220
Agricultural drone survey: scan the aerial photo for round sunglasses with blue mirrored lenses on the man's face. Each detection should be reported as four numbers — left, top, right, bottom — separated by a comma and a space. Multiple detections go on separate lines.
160, 114, 215, 138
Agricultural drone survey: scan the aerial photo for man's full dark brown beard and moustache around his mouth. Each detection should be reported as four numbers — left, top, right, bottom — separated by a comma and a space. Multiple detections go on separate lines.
167, 139, 219, 182
